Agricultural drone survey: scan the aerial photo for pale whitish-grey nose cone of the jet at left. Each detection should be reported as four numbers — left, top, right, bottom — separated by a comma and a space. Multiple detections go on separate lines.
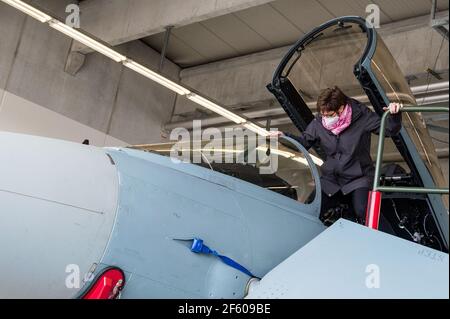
0, 133, 119, 298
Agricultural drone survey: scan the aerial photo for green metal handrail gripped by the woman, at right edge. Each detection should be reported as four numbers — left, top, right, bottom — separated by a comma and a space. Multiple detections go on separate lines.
373, 106, 449, 195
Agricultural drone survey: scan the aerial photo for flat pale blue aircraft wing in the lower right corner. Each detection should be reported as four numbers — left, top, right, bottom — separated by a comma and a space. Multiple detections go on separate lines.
247, 219, 449, 299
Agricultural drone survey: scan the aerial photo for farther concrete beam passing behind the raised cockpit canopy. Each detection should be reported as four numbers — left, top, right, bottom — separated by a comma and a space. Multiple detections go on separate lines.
172, 11, 449, 122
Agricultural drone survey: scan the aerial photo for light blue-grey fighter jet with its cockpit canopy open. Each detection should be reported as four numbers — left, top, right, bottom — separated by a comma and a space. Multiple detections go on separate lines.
0, 17, 448, 299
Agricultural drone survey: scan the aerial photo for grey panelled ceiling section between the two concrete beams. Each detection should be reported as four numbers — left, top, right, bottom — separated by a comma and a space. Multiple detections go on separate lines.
142, 0, 449, 68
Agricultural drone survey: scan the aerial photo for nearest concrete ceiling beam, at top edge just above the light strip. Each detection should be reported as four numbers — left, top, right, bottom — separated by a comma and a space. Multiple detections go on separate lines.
72, 0, 273, 53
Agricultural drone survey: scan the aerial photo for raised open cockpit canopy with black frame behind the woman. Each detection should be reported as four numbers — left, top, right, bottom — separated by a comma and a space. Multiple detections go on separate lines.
267, 17, 448, 250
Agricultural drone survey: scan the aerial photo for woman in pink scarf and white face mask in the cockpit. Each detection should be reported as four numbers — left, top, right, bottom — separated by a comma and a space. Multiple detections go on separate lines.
272, 86, 402, 223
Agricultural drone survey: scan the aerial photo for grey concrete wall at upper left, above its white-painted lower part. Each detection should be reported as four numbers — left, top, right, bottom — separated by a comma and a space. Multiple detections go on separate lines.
0, 1, 180, 144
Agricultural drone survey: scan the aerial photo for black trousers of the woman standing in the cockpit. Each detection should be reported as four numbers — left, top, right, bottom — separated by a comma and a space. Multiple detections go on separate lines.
321, 188, 369, 224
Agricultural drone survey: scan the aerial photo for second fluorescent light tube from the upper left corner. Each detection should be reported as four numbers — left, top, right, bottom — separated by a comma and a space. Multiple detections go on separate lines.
49, 20, 127, 62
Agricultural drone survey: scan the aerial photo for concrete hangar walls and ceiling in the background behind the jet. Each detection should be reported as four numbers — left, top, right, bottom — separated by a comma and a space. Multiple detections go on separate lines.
0, 0, 449, 183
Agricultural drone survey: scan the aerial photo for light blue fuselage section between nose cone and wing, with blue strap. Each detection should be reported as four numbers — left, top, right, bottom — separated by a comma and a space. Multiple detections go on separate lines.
99, 149, 325, 298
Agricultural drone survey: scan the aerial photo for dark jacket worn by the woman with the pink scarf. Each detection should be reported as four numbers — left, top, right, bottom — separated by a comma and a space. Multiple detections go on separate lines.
286, 99, 402, 196
